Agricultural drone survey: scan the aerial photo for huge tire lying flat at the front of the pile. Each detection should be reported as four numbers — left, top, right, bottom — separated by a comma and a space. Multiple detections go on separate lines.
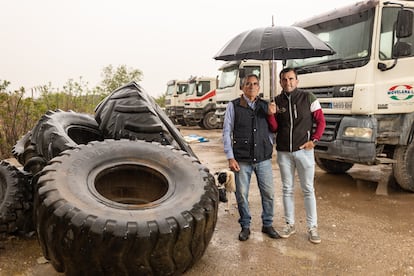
35, 140, 218, 275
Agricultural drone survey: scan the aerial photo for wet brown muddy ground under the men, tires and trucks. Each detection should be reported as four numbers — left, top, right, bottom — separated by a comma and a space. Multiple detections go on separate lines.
0, 127, 414, 276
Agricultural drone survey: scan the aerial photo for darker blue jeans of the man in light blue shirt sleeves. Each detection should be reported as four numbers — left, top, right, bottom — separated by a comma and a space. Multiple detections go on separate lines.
234, 159, 275, 228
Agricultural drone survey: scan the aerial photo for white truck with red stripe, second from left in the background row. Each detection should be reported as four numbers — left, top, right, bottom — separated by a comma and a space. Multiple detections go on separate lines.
184, 76, 218, 129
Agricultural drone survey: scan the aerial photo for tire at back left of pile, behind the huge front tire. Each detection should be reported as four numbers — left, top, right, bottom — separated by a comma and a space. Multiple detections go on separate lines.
20, 110, 103, 174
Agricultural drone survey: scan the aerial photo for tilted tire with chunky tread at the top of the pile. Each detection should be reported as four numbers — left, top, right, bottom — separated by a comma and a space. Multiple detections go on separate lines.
95, 82, 196, 157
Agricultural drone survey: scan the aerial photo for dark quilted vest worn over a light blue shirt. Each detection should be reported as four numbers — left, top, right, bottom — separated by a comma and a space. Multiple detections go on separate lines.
232, 96, 273, 163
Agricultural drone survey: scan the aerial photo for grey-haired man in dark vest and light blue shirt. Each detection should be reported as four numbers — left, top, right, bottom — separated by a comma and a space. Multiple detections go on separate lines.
223, 75, 280, 241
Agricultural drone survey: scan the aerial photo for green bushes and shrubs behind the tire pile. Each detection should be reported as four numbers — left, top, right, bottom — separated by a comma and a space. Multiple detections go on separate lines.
0, 65, 165, 159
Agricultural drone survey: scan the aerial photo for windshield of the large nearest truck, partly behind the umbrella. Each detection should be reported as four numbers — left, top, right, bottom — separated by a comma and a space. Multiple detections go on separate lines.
287, 8, 375, 74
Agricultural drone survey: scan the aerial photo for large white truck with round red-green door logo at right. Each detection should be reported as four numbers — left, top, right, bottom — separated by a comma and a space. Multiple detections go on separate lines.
287, 0, 414, 191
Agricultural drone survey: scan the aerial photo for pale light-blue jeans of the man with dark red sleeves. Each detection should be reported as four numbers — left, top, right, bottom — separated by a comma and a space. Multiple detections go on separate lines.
277, 149, 318, 228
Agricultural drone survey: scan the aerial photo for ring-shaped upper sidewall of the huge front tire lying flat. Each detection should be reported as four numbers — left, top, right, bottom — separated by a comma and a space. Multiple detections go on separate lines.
39, 140, 207, 222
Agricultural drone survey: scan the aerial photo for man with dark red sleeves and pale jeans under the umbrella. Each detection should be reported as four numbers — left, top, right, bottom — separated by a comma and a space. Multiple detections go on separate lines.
269, 68, 326, 244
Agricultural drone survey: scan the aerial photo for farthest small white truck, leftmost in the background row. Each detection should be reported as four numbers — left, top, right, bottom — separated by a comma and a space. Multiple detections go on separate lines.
165, 80, 189, 126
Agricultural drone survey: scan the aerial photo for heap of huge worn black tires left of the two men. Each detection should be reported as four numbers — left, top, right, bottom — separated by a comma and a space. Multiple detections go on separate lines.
0, 82, 218, 275
